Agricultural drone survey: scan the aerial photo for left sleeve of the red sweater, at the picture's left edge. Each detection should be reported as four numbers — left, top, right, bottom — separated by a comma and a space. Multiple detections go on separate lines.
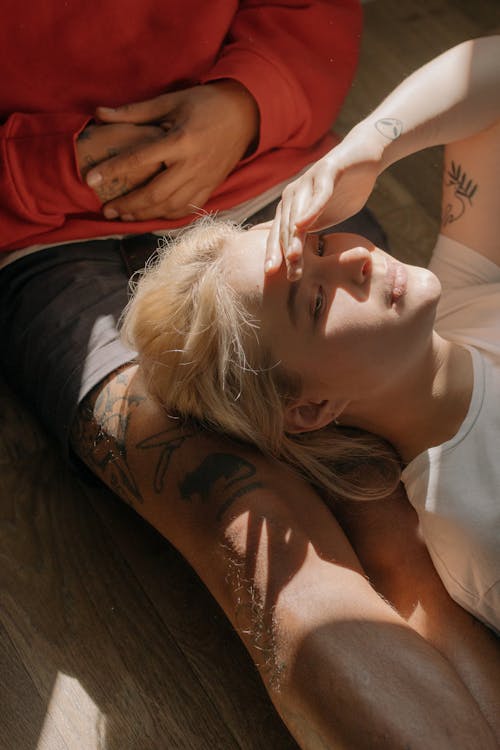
0, 113, 100, 246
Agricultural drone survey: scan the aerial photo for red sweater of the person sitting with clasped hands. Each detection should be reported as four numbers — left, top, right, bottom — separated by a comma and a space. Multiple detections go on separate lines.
0, 0, 361, 251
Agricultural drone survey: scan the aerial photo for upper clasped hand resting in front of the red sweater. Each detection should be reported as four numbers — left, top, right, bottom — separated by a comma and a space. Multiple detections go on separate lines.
87, 80, 259, 221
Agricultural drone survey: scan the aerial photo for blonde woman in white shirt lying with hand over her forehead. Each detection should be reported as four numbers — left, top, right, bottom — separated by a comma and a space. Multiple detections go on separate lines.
124, 37, 500, 630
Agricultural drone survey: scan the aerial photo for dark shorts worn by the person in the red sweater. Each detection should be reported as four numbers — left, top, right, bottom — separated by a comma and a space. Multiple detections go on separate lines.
0, 201, 385, 452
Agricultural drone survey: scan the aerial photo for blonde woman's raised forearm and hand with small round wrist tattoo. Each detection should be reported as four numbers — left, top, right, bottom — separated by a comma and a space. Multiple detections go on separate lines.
266, 36, 500, 278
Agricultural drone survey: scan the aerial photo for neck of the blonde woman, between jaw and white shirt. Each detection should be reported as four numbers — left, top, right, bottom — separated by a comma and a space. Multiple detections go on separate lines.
341, 333, 473, 463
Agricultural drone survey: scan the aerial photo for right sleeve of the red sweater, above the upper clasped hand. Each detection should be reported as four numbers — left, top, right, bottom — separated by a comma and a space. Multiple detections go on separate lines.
203, 0, 362, 157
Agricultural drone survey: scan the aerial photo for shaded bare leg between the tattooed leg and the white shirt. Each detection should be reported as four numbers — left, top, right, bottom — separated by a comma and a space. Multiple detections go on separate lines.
334, 485, 500, 738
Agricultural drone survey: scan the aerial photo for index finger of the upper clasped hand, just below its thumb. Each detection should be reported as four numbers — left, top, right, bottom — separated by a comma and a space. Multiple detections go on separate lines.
85, 135, 173, 189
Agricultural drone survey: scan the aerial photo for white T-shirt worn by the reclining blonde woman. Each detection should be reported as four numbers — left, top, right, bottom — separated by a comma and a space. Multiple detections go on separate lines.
403, 236, 500, 632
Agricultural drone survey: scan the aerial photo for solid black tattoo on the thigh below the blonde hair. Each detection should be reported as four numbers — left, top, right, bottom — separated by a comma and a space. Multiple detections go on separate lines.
179, 453, 262, 520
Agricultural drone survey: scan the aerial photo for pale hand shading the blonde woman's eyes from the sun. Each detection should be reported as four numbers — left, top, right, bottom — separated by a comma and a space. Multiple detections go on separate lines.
265, 131, 380, 280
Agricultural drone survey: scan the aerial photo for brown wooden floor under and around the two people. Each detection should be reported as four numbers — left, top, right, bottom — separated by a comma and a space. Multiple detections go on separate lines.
0, 0, 500, 750
